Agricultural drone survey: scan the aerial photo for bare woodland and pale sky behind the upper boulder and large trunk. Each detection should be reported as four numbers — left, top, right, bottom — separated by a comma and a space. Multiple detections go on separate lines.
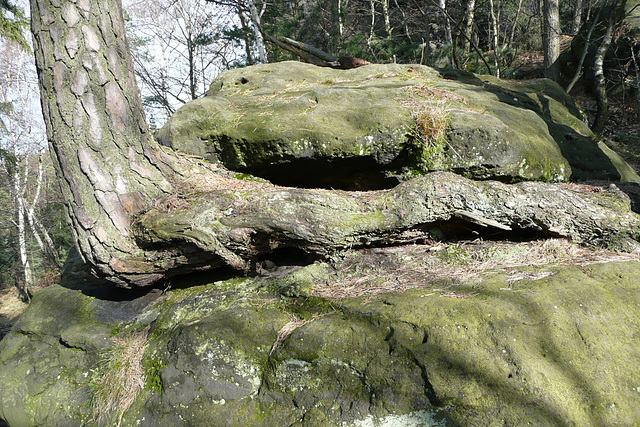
0, 0, 640, 300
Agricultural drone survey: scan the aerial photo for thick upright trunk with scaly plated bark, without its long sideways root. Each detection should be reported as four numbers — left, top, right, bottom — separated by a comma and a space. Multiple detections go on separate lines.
31, 0, 172, 286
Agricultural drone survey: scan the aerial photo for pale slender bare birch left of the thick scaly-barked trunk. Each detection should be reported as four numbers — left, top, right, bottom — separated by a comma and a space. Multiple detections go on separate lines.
0, 42, 60, 299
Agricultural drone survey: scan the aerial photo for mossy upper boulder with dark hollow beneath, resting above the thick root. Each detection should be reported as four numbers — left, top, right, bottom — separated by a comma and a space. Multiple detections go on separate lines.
158, 62, 638, 189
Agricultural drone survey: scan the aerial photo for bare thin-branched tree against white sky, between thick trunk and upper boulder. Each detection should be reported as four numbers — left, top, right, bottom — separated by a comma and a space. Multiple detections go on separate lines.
125, 0, 240, 124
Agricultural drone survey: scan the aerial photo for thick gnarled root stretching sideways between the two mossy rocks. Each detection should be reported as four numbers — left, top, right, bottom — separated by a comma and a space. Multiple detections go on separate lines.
110, 172, 640, 285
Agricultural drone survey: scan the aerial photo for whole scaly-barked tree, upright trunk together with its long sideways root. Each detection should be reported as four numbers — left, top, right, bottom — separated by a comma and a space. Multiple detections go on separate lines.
31, 0, 640, 287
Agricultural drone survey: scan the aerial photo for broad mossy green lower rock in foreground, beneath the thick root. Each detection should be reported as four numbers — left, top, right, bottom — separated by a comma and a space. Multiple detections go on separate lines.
0, 256, 640, 426
